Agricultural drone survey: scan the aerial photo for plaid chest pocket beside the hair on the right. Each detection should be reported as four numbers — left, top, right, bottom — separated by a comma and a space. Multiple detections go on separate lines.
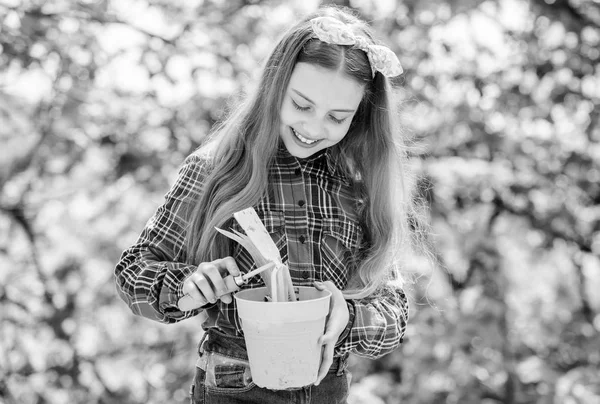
320, 218, 363, 289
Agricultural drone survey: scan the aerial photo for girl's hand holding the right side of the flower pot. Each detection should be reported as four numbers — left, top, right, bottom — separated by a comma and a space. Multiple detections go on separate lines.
314, 281, 350, 386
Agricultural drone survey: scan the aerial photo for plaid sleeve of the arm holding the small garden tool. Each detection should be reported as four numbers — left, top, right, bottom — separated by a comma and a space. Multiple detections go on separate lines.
115, 155, 214, 323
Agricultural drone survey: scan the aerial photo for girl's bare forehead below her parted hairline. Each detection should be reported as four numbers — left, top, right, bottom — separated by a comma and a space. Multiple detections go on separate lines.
288, 63, 364, 110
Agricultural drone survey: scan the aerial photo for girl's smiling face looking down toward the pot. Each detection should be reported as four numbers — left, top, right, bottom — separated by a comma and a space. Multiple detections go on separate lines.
280, 63, 364, 158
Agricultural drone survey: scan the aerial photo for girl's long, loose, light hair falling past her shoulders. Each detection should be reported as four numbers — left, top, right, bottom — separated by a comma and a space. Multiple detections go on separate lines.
186, 6, 411, 298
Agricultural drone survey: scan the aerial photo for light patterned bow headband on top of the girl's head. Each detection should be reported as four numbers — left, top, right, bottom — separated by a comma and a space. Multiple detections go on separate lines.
310, 17, 404, 77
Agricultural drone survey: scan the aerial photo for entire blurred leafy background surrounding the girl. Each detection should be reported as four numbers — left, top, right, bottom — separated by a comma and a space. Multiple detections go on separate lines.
0, 0, 600, 404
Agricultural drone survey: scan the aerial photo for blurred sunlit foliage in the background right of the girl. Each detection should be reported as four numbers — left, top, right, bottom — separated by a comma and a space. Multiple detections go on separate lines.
350, 1, 600, 403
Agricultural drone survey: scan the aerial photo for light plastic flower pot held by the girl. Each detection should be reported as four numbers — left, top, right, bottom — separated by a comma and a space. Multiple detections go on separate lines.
234, 287, 331, 390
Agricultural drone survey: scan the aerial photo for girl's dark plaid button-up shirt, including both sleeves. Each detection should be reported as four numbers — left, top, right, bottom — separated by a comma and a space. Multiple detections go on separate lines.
115, 147, 408, 358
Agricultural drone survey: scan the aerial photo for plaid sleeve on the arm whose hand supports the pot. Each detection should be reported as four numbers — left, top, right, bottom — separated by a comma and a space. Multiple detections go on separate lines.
336, 283, 408, 359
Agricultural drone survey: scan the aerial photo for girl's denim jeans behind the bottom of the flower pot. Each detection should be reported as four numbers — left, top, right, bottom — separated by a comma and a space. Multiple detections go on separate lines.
190, 328, 351, 404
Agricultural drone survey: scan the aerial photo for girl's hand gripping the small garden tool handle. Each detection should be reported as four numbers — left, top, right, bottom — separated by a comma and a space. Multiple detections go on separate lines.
183, 257, 240, 307
